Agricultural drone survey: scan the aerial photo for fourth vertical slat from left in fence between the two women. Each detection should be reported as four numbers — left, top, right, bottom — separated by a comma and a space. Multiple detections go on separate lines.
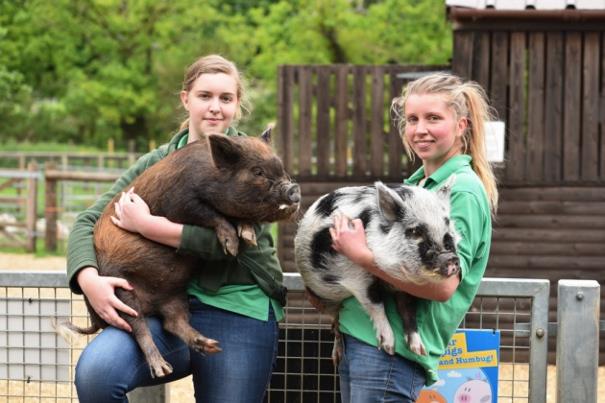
334, 64, 349, 177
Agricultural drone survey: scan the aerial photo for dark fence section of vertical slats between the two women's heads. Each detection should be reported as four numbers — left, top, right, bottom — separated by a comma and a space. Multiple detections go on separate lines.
278, 65, 449, 181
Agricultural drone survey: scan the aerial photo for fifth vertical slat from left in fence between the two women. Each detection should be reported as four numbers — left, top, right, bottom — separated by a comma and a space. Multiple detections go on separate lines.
353, 66, 367, 176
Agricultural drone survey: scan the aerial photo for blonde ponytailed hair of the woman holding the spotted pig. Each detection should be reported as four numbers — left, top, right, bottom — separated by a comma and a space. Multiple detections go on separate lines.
392, 73, 498, 213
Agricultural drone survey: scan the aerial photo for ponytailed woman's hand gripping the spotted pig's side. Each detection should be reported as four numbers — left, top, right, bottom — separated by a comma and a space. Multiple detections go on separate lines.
330, 212, 374, 268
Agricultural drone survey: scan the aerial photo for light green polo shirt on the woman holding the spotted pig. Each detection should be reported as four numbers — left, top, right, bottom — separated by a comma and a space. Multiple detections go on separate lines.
340, 155, 492, 385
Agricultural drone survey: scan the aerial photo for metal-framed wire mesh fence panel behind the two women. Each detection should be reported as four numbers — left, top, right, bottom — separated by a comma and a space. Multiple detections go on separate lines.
0, 271, 549, 403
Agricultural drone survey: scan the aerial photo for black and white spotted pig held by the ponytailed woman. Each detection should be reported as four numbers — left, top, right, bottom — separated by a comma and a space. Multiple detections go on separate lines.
294, 177, 460, 359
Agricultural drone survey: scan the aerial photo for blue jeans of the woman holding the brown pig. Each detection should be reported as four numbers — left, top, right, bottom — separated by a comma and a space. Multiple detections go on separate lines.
75, 298, 279, 403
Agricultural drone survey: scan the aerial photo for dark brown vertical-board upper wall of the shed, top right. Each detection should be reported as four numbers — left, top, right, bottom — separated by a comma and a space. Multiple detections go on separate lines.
452, 13, 605, 185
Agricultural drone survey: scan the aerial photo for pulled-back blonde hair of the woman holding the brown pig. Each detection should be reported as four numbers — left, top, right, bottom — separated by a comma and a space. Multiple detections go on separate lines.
179, 55, 249, 130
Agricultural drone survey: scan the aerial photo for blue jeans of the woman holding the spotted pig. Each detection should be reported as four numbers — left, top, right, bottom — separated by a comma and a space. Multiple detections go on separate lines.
338, 334, 426, 403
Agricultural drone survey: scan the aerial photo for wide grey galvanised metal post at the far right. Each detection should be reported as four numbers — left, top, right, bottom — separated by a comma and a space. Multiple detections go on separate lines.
557, 280, 601, 403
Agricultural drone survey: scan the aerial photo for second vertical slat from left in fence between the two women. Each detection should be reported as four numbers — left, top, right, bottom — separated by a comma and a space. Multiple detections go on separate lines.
298, 66, 312, 175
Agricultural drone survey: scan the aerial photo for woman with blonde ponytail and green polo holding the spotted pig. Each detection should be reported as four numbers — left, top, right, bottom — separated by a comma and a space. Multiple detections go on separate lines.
332, 73, 498, 403
